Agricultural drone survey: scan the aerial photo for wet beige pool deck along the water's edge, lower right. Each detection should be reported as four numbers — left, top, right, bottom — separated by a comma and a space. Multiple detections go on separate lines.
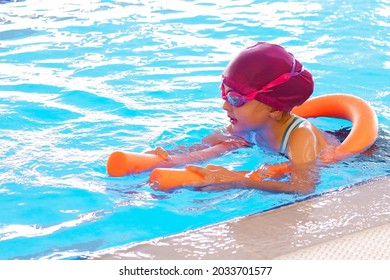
93, 176, 390, 260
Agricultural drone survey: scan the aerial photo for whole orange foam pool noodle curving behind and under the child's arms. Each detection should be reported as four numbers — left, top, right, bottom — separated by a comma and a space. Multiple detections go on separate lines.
107, 94, 378, 190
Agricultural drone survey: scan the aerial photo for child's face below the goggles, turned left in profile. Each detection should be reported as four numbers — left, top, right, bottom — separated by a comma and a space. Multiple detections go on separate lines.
222, 85, 272, 133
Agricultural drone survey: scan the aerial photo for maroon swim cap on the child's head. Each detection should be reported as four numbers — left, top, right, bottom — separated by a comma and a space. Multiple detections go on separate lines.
222, 42, 314, 111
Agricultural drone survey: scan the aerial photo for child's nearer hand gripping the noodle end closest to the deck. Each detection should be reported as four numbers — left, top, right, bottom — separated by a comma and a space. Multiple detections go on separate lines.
186, 165, 242, 190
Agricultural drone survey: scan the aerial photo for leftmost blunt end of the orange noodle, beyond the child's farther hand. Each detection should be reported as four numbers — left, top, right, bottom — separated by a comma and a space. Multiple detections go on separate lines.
107, 151, 163, 177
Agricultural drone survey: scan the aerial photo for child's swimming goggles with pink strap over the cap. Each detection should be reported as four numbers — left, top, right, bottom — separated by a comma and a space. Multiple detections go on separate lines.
221, 53, 305, 107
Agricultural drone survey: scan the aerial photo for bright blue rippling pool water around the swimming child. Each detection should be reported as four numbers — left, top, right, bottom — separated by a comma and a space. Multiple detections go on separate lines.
0, 0, 390, 259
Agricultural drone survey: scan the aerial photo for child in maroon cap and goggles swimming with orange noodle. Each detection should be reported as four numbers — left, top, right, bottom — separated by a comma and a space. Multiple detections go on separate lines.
148, 42, 337, 193
